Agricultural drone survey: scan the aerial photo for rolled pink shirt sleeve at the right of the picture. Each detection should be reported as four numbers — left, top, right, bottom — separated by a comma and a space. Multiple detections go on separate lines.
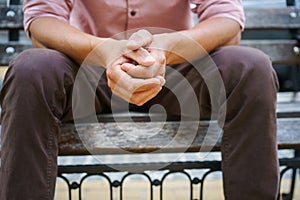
190, 0, 245, 30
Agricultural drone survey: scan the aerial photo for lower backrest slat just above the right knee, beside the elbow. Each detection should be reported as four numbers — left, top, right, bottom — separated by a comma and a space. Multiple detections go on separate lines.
241, 40, 300, 64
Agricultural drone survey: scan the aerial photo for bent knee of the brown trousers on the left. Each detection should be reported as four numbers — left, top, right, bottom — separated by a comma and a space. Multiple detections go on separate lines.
1, 49, 77, 118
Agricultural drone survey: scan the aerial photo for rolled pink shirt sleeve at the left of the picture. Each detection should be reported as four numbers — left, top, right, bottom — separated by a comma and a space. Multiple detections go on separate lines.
23, 0, 73, 34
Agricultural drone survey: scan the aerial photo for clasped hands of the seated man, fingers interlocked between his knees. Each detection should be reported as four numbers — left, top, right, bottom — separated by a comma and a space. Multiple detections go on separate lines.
106, 30, 166, 106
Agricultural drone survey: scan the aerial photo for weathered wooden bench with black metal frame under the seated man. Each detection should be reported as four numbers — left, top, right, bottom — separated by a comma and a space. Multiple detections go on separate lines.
0, 0, 300, 199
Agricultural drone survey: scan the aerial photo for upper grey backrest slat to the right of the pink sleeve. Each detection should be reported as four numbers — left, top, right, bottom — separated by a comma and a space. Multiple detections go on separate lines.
245, 7, 300, 30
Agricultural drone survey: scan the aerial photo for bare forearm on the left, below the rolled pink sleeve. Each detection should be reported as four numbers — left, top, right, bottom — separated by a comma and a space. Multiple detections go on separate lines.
29, 17, 106, 64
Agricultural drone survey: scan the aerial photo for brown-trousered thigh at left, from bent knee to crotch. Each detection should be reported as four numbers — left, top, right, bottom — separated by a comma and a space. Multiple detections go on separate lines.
1, 48, 115, 122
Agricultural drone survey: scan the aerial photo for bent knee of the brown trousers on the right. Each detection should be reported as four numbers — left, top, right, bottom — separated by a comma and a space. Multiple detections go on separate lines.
215, 46, 279, 101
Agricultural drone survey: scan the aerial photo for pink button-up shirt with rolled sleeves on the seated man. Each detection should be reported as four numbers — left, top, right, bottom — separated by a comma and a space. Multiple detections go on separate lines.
23, 0, 245, 37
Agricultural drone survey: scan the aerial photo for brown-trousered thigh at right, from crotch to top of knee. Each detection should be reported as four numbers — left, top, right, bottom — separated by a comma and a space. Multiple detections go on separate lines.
132, 46, 274, 119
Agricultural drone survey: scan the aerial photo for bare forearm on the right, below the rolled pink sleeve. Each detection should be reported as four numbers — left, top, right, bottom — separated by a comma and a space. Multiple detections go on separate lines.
154, 18, 241, 64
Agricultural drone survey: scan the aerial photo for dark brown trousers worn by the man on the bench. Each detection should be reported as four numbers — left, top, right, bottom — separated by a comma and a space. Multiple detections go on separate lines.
0, 46, 279, 200
